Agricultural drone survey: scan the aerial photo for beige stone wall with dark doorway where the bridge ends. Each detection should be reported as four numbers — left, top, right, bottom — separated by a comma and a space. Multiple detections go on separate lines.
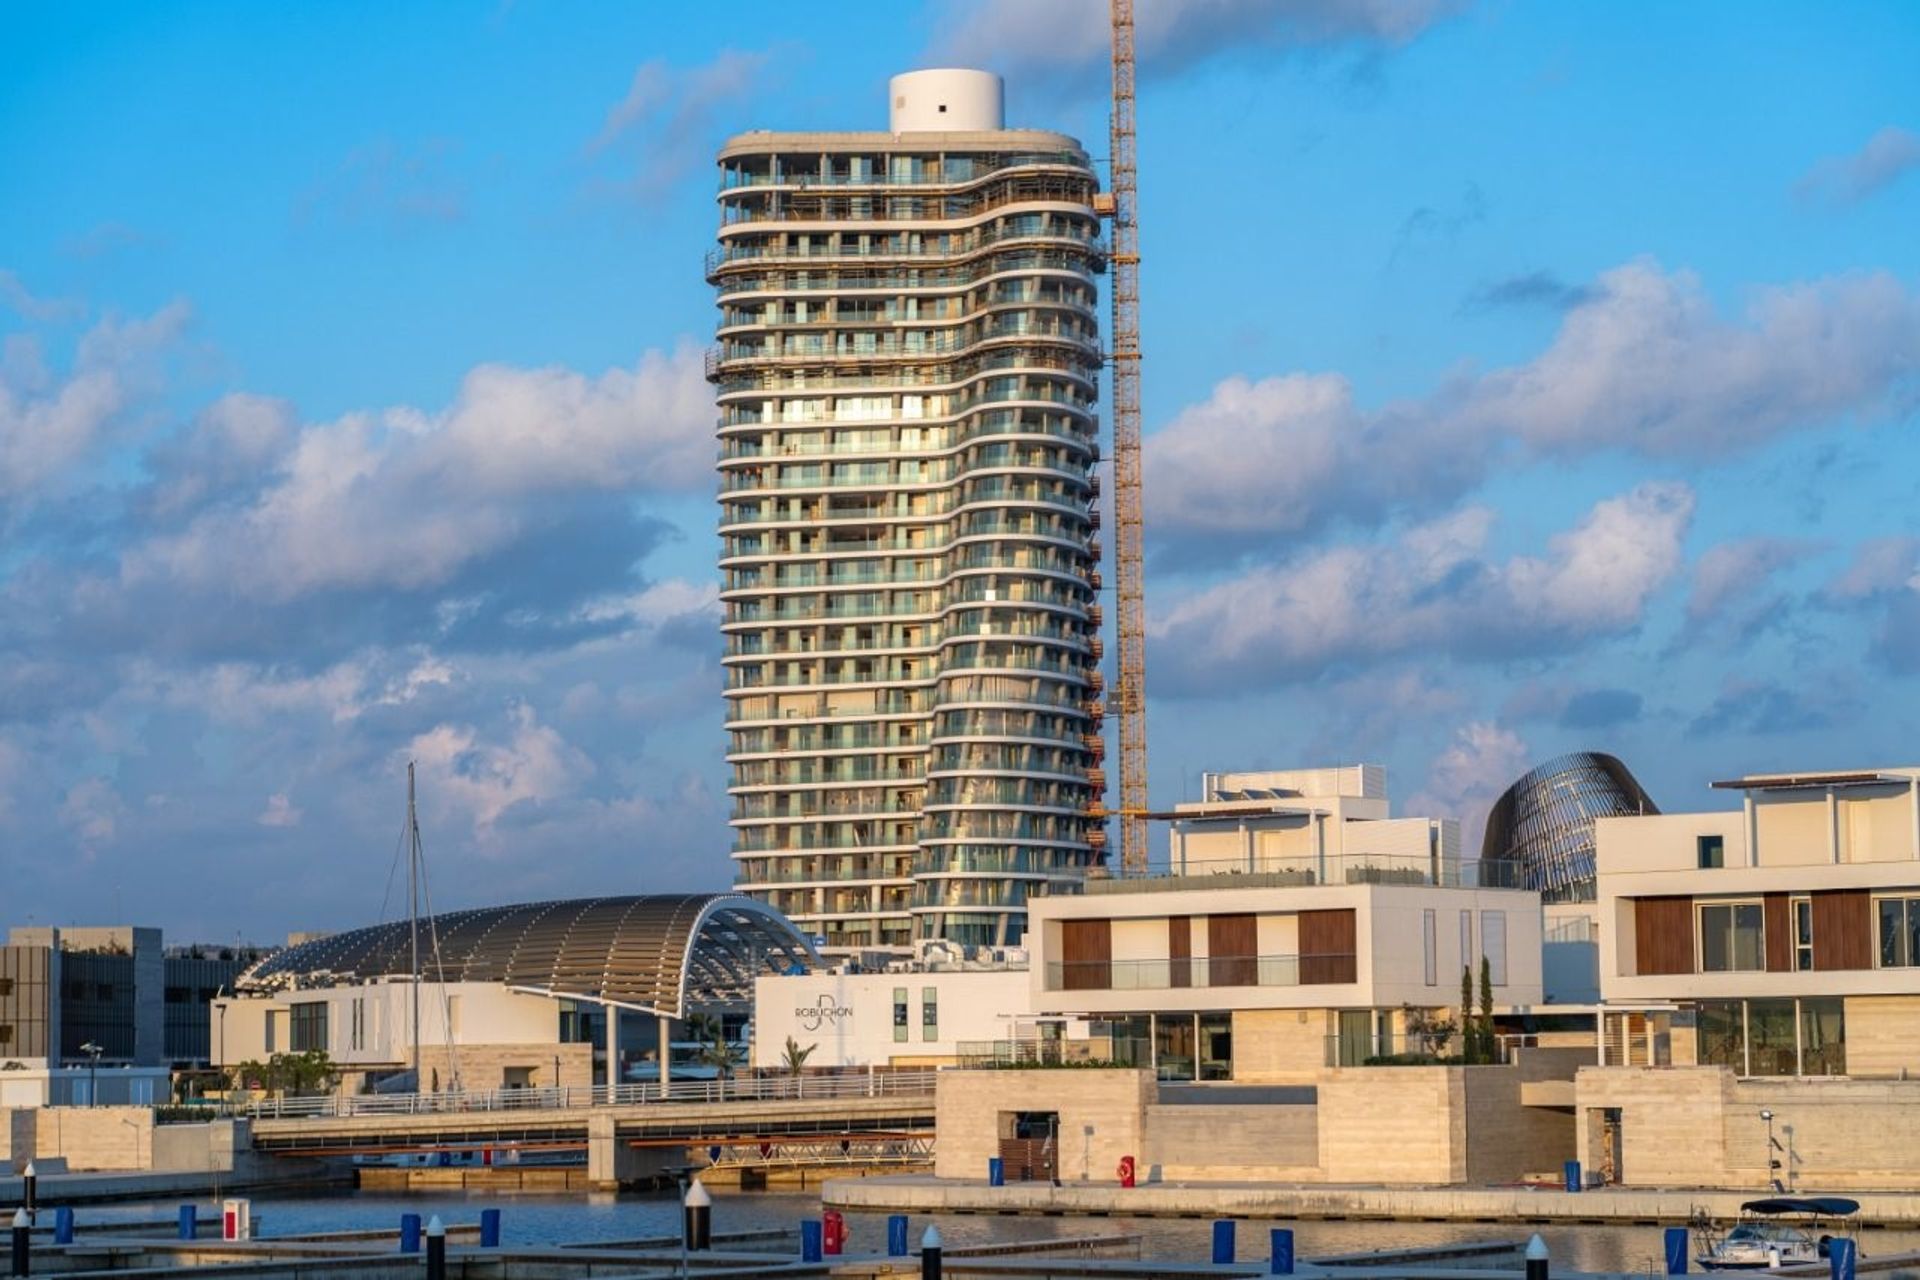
933, 1067, 1158, 1180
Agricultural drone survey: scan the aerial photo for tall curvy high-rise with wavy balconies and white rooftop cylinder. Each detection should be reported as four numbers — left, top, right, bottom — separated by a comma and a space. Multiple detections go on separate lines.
708, 71, 1106, 950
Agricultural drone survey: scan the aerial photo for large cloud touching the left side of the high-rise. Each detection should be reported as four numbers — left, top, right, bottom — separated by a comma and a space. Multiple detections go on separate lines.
123, 344, 712, 603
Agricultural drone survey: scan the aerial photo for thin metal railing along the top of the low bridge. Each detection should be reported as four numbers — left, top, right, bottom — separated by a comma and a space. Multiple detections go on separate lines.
238, 1069, 939, 1119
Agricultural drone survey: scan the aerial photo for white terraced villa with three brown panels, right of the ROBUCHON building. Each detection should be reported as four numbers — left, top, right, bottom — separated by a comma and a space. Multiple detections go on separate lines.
1027, 766, 1542, 1082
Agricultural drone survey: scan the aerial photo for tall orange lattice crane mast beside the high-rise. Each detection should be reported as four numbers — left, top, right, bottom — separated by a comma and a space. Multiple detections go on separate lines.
1110, 0, 1146, 875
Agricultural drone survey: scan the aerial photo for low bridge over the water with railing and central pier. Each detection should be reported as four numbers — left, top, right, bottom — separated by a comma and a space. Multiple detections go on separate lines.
244, 1071, 935, 1186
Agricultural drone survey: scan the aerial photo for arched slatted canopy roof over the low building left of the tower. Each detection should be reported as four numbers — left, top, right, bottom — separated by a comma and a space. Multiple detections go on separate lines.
238, 894, 818, 1017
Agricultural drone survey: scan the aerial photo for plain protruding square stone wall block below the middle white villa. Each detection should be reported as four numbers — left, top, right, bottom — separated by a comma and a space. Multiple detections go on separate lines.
1319, 1067, 1467, 1186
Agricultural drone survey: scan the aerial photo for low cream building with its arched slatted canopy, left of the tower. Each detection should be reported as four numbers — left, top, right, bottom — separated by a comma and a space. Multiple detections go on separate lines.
213, 894, 816, 1092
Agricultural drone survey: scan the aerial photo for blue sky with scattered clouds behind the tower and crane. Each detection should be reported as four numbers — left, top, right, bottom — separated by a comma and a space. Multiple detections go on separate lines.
0, 0, 1920, 938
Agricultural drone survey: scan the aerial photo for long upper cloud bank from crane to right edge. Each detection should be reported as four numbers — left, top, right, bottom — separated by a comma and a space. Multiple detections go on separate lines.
1146, 261, 1920, 537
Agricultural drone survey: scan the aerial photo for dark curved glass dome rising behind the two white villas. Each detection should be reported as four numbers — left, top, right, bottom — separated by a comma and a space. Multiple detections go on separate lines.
1480, 750, 1661, 902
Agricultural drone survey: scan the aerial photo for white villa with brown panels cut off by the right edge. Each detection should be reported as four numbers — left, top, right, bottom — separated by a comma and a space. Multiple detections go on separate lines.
1597, 768, 1920, 1077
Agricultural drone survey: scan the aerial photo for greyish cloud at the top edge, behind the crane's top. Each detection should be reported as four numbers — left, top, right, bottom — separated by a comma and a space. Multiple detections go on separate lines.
937, 0, 1465, 73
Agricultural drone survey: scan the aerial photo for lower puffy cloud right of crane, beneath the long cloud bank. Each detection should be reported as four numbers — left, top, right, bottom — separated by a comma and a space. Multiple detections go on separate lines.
1154, 484, 1693, 687
